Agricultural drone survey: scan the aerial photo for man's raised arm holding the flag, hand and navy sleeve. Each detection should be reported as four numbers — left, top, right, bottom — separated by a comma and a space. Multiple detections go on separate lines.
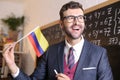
3, 43, 45, 80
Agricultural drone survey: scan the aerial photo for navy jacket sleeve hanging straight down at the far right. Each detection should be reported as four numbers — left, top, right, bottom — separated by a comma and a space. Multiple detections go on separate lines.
97, 49, 113, 80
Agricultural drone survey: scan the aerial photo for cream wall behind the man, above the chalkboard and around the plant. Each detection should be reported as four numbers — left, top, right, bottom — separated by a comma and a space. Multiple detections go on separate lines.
0, 0, 107, 74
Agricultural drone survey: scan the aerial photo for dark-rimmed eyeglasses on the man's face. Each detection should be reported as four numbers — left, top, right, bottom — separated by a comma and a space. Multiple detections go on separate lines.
63, 15, 84, 23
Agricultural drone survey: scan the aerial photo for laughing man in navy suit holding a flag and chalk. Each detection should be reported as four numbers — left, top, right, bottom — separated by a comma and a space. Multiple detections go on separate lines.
3, 1, 113, 80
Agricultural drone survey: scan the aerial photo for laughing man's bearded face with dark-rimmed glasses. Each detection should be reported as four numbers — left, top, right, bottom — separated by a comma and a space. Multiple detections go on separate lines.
61, 8, 85, 39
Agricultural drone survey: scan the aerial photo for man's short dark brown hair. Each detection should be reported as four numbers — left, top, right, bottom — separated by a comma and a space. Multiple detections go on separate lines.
59, 1, 84, 20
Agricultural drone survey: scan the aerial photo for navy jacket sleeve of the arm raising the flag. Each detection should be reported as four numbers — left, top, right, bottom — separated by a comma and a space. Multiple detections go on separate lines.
13, 50, 47, 80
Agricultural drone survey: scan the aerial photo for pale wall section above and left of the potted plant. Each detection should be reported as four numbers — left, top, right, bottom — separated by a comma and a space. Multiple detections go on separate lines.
0, 0, 24, 35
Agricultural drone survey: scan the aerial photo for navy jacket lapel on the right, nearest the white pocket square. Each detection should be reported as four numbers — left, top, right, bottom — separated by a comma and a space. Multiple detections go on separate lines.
73, 40, 90, 80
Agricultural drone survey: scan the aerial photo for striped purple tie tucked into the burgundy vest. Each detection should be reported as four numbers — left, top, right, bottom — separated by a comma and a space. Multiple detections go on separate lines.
68, 47, 75, 69
